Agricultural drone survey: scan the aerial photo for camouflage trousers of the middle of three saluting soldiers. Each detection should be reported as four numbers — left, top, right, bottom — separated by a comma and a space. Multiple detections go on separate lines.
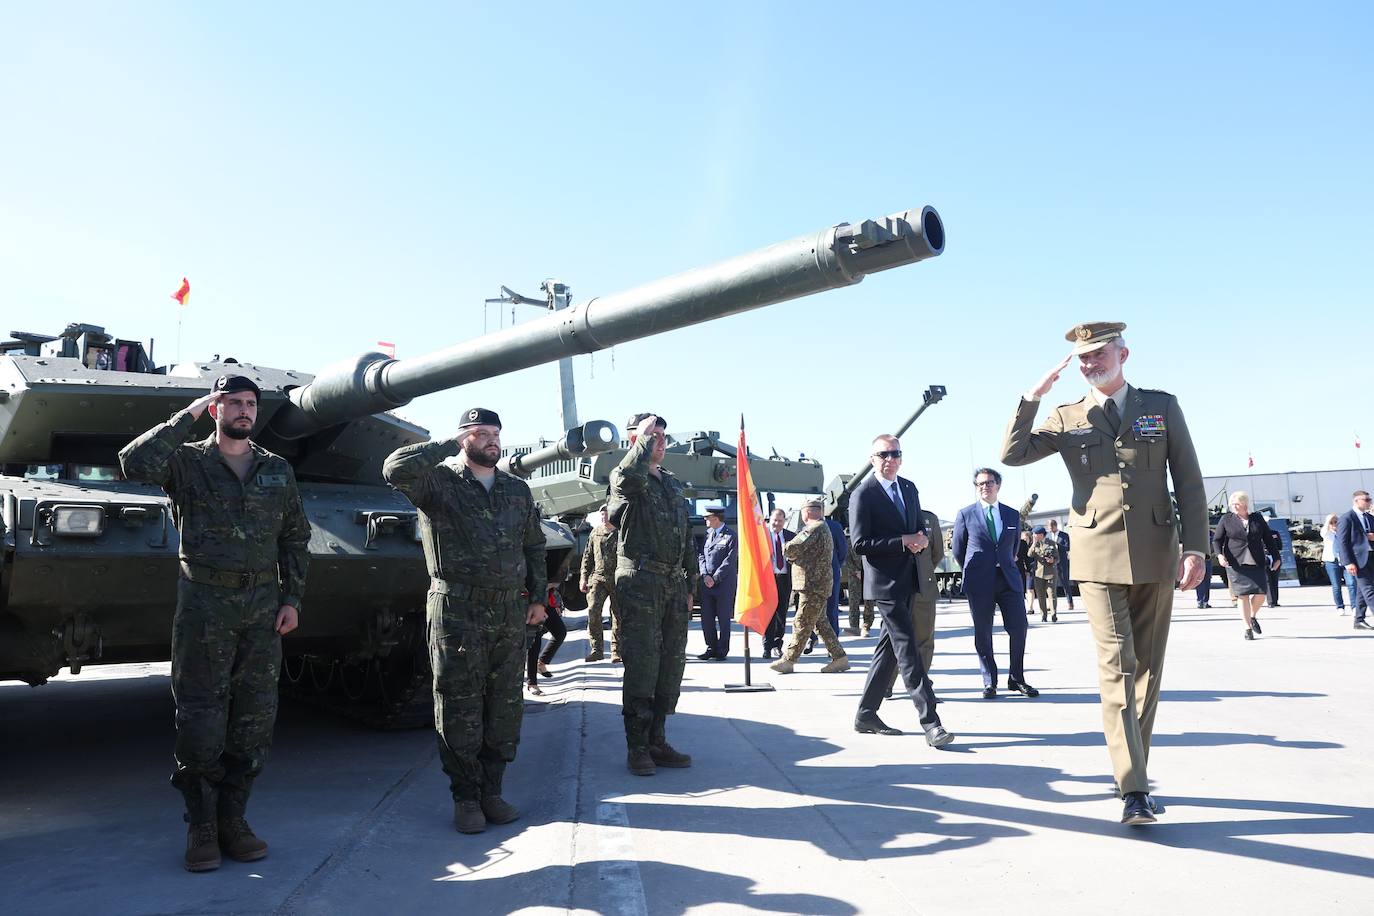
426, 592, 529, 801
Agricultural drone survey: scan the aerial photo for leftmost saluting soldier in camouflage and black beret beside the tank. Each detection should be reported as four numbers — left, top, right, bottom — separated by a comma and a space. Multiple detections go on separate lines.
120, 375, 311, 872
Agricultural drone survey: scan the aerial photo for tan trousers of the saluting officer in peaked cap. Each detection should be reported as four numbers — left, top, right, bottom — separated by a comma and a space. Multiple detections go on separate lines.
1079, 582, 1173, 794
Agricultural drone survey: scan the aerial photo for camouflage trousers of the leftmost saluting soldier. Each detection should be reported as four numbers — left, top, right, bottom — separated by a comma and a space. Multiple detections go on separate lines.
172, 578, 282, 824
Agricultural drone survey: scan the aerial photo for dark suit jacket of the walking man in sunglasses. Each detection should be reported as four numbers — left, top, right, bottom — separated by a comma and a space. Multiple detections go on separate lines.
849, 474, 930, 602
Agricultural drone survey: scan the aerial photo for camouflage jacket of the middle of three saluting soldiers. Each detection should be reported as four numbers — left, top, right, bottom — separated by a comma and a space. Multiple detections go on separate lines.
382, 439, 548, 603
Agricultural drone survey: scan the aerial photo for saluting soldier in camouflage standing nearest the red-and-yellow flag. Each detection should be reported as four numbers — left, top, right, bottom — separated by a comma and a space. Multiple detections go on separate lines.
610, 413, 697, 776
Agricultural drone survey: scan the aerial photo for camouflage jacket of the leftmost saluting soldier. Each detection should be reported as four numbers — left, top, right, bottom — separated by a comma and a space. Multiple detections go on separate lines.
120, 411, 311, 608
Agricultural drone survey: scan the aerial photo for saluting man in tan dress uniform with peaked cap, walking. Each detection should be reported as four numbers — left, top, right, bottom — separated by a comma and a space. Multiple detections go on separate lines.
1002, 321, 1208, 824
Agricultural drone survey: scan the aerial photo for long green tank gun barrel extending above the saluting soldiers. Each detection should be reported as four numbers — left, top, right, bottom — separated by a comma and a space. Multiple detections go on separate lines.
271, 206, 945, 439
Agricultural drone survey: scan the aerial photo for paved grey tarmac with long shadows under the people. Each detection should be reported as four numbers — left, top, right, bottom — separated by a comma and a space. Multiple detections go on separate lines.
0, 588, 1374, 916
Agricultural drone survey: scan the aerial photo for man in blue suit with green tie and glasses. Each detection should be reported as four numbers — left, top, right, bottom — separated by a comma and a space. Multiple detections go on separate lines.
952, 467, 1040, 700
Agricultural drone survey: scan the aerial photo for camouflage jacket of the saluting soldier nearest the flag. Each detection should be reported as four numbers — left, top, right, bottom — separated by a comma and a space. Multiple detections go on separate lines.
609, 435, 697, 578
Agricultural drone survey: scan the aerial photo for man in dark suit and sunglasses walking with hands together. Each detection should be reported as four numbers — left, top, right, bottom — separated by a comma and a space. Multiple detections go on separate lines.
849, 435, 954, 747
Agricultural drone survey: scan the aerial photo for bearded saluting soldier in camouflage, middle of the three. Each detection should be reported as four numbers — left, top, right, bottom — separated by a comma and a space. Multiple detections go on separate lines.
382, 408, 548, 834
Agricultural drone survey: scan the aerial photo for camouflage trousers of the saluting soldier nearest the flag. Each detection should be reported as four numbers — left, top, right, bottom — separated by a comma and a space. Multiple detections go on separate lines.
616, 569, 691, 750
